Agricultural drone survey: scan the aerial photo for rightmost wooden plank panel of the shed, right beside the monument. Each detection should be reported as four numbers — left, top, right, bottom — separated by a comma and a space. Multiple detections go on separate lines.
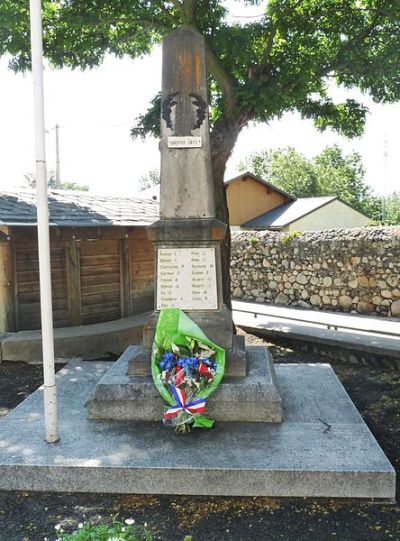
129, 228, 154, 314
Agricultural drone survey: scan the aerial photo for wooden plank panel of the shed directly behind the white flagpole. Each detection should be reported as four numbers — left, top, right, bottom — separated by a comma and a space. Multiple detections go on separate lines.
14, 239, 70, 330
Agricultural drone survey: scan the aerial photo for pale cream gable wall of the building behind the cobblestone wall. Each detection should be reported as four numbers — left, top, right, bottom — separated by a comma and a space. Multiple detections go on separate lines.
284, 199, 370, 231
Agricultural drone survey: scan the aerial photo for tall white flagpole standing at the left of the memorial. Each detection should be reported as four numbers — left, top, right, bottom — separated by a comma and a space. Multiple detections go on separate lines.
29, 0, 59, 443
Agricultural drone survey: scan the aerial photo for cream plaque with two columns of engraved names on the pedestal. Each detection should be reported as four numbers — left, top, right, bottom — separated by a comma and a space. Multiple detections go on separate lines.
157, 248, 218, 310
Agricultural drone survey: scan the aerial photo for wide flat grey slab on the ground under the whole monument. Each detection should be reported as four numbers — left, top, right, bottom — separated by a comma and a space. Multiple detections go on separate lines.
0, 361, 395, 500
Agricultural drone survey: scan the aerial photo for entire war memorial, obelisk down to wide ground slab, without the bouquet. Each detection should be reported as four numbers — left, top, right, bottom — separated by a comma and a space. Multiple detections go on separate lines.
0, 27, 395, 500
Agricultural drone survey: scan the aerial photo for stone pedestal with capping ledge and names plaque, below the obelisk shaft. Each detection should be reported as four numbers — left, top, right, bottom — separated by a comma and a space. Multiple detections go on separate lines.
137, 218, 246, 376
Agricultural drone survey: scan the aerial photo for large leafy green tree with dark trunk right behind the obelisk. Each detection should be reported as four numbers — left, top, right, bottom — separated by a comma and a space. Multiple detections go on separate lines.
0, 0, 400, 297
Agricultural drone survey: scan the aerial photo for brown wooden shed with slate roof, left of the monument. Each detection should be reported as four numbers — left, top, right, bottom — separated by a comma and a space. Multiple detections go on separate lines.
0, 190, 158, 332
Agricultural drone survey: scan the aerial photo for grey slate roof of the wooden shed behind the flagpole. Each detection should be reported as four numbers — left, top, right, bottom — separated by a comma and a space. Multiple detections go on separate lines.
0, 189, 159, 227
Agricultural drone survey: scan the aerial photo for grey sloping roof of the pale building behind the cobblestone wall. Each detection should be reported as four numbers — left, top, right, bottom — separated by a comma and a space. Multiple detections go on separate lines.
243, 196, 337, 229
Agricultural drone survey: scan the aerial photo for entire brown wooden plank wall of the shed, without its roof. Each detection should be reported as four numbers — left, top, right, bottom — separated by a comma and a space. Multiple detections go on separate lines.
10, 228, 154, 330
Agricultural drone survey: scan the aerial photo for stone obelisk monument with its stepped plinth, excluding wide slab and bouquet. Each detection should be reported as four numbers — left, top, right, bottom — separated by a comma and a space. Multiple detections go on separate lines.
88, 27, 282, 422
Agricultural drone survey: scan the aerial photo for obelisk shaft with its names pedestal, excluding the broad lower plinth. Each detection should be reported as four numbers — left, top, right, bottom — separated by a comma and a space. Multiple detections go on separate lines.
143, 26, 245, 375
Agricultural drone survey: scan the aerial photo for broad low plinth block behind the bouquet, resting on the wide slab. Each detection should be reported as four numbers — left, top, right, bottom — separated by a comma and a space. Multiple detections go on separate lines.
88, 346, 282, 423
